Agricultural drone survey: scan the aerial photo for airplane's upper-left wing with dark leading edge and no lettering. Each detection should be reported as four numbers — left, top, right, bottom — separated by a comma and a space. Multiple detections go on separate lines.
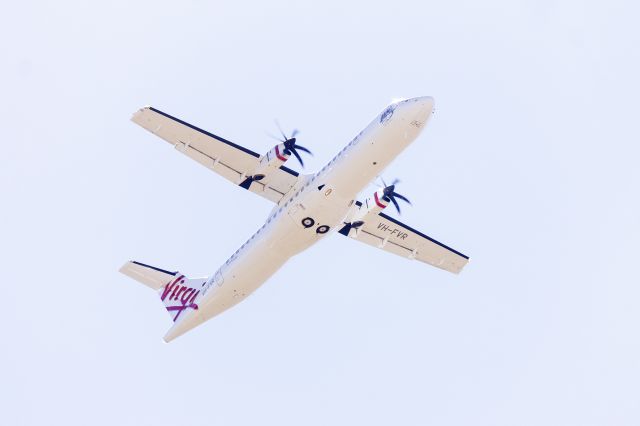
131, 107, 298, 203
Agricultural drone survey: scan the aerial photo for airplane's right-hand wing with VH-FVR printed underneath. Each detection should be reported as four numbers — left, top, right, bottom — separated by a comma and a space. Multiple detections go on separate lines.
339, 212, 469, 274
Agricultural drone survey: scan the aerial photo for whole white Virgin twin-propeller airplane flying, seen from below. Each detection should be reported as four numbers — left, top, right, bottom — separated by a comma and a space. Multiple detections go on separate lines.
120, 97, 469, 342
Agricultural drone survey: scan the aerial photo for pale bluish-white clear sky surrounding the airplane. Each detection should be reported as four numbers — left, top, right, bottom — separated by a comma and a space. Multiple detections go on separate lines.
0, 1, 640, 426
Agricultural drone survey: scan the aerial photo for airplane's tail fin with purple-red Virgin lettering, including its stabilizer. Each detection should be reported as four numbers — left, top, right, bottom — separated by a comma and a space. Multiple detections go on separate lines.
120, 261, 207, 322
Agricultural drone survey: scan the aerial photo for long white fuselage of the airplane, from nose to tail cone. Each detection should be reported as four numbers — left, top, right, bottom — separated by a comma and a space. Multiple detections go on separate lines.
165, 97, 433, 341
